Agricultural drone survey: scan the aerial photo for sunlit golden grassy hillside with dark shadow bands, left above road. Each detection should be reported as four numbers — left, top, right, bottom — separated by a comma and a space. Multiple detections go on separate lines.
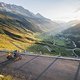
0, 14, 36, 50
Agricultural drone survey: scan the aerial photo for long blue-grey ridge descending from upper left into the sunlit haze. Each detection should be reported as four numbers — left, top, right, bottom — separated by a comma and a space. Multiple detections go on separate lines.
0, 2, 59, 31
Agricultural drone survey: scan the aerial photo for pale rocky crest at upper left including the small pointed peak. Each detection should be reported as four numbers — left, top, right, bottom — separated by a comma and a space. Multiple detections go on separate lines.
0, 2, 46, 19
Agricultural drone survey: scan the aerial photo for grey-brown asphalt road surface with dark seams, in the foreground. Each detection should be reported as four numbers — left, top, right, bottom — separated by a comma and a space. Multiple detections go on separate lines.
0, 53, 80, 80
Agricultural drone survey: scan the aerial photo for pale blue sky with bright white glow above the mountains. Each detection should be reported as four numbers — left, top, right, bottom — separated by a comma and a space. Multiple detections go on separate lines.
0, 0, 80, 22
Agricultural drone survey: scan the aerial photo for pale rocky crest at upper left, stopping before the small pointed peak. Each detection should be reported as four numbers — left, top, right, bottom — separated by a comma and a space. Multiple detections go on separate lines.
0, 2, 34, 17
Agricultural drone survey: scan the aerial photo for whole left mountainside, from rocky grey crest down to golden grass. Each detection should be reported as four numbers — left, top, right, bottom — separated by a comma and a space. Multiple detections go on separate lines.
0, 2, 59, 50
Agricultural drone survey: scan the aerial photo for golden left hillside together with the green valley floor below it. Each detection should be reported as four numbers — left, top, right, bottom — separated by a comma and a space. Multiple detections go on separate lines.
0, 11, 72, 56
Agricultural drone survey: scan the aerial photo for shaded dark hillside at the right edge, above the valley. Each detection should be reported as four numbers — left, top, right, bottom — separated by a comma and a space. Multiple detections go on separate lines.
63, 22, 80, 48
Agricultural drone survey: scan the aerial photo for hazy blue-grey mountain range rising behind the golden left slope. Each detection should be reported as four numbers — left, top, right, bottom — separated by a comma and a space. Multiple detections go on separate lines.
0, 2, 60, 32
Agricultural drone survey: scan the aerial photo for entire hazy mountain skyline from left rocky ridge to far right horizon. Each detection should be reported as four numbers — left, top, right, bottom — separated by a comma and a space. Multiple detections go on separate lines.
0, 2, 79, 33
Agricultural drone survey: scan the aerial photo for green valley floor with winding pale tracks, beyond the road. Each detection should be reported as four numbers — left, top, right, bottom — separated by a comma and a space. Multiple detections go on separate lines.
29, 35, 73, 56
